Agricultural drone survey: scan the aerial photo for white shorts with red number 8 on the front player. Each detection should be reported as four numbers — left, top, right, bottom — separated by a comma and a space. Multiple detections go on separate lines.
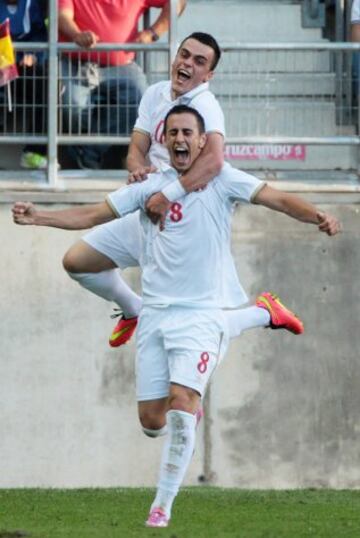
136, 306, 228, 401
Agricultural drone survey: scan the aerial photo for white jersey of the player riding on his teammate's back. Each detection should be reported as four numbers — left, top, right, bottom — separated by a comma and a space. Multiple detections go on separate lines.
134, 80, 225, 170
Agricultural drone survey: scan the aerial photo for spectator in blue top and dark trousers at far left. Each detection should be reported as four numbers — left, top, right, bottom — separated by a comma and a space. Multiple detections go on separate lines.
0, 0, 47, 169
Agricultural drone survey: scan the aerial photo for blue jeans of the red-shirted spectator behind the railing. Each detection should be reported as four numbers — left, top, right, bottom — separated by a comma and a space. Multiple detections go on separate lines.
61, 57, 146, 168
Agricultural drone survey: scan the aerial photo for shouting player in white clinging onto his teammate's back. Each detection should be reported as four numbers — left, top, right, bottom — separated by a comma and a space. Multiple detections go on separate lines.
63, 32, 303, 347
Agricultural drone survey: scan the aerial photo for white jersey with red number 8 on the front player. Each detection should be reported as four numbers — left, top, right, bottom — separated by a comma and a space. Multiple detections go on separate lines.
107, 164, 264, 308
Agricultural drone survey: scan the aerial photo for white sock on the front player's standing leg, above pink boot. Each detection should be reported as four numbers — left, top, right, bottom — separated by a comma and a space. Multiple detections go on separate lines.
151, 409, 196, 519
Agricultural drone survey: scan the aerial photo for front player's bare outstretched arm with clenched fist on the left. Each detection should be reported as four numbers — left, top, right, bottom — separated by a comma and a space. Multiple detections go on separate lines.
12, 202, 116, 230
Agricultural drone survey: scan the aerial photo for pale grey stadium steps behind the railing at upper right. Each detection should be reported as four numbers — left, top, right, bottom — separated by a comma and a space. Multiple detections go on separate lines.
161, 0, 359, 181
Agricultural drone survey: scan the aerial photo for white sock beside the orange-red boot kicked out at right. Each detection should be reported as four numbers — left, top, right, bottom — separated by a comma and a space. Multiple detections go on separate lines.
223, 306, 270, 338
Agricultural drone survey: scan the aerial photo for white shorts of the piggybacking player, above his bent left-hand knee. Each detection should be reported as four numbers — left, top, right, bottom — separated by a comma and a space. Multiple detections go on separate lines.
82, 211, 142, 269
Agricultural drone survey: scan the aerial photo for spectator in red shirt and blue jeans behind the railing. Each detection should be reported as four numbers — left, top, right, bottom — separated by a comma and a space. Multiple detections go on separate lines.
58, 0, 186, 169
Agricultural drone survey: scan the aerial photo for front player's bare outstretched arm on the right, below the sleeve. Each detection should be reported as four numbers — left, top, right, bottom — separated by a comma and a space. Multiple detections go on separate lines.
253, 185, 341, 235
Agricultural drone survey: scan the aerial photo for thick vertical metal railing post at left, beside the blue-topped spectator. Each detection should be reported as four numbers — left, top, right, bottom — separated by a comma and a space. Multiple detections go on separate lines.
47, 0, 58, 188
